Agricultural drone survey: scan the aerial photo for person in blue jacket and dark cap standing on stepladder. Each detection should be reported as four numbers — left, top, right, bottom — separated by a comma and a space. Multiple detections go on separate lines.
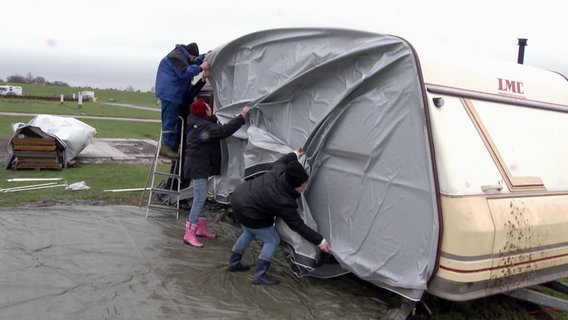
154, 42, 209, 159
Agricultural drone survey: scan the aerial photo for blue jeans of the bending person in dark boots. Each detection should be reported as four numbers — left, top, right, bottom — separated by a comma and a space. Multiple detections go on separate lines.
233, 224, 280, 261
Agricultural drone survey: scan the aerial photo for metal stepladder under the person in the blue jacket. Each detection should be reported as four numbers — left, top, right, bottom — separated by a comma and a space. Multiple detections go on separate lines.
140, 117, 189, 219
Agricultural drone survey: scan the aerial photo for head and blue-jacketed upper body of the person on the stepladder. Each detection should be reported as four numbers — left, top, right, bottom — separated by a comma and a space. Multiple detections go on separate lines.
154, 44, 205, 104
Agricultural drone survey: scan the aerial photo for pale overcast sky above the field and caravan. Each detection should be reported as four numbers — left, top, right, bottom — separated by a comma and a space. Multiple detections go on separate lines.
0, 0, 568, 91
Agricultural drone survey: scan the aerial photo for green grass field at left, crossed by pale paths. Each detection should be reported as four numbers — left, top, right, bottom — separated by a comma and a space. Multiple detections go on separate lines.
0, 85, 164, 207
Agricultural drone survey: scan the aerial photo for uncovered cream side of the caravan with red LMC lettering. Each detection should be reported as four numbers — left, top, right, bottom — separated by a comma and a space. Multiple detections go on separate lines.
423, 52, 568, 301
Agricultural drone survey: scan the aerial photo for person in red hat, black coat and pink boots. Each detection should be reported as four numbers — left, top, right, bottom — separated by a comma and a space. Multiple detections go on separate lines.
183, 100, 250, 248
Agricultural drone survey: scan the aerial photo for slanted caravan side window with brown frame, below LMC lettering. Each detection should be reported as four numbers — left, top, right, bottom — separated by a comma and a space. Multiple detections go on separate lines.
462, 99, 568, 190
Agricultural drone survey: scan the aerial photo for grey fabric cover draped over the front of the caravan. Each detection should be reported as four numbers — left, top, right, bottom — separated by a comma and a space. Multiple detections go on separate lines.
207, 28, 439, 300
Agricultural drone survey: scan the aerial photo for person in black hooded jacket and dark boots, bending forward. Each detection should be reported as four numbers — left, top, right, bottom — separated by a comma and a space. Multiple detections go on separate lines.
227, 148, 330, 285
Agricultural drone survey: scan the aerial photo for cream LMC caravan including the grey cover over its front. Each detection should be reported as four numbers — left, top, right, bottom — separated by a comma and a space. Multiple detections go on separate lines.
200, 28, 568, 301
